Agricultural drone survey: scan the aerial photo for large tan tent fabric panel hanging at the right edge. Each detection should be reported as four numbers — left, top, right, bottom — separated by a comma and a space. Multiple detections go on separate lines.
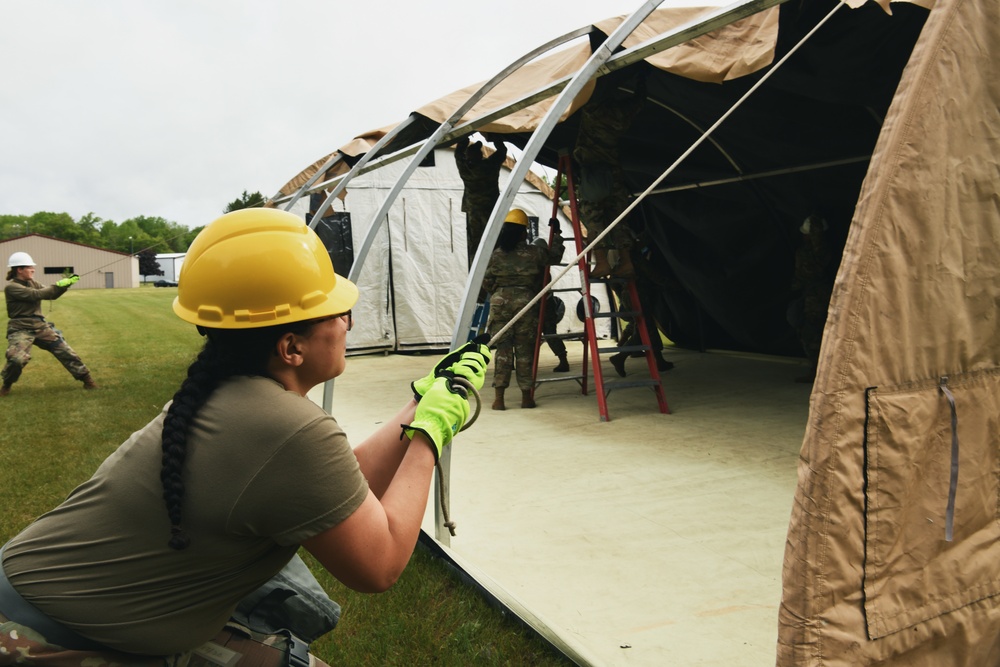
778, 0, 1000, 667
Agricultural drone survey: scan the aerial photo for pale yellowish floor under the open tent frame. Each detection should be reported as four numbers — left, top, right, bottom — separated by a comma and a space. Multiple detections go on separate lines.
320, 346, 810, 667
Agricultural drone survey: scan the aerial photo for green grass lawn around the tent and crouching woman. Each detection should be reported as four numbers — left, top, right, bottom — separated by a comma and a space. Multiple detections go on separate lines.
0, 288, 571, 666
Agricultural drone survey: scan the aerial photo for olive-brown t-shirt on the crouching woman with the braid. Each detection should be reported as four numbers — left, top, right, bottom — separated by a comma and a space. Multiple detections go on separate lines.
3, 377, 368, 655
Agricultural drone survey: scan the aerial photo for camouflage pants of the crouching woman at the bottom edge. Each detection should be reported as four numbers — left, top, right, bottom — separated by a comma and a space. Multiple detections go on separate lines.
0, 615, 329, 667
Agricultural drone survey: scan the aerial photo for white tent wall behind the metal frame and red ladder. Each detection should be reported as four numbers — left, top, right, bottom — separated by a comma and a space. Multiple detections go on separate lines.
292, 148, 609, 353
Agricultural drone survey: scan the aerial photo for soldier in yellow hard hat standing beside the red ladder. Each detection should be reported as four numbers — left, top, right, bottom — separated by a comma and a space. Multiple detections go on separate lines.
483, 208, 563, 410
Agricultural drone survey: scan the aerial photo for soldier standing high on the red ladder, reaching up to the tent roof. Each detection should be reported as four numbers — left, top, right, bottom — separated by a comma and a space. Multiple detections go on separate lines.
573, 78, 646, 278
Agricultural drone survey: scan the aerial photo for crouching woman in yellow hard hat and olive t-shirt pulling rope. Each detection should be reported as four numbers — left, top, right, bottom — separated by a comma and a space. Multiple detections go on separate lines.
0, 209, 490, 665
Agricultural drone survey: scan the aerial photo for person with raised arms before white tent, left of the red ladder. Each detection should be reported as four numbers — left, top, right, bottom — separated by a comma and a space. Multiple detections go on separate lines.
455, 137, 507, 265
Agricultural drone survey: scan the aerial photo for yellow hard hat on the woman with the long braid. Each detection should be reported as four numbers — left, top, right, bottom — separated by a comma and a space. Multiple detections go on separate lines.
174, 208, 358, 329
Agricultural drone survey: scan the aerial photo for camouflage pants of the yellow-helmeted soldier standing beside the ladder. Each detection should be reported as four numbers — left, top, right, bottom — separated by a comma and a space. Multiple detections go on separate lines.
489, 288, 538, 391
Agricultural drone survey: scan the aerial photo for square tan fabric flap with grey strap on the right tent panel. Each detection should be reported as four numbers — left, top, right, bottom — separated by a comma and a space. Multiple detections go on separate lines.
864, 369, 1000, 639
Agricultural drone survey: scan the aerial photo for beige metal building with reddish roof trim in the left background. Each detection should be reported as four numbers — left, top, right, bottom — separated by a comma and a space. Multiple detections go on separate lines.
0, 234, 139, 289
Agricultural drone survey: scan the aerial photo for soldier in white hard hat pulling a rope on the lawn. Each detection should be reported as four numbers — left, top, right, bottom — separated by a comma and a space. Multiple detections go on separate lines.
0, 252, 97, 396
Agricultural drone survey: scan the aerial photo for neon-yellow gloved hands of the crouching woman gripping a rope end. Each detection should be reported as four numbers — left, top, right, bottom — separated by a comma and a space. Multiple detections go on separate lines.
402, 335, 493, 535
